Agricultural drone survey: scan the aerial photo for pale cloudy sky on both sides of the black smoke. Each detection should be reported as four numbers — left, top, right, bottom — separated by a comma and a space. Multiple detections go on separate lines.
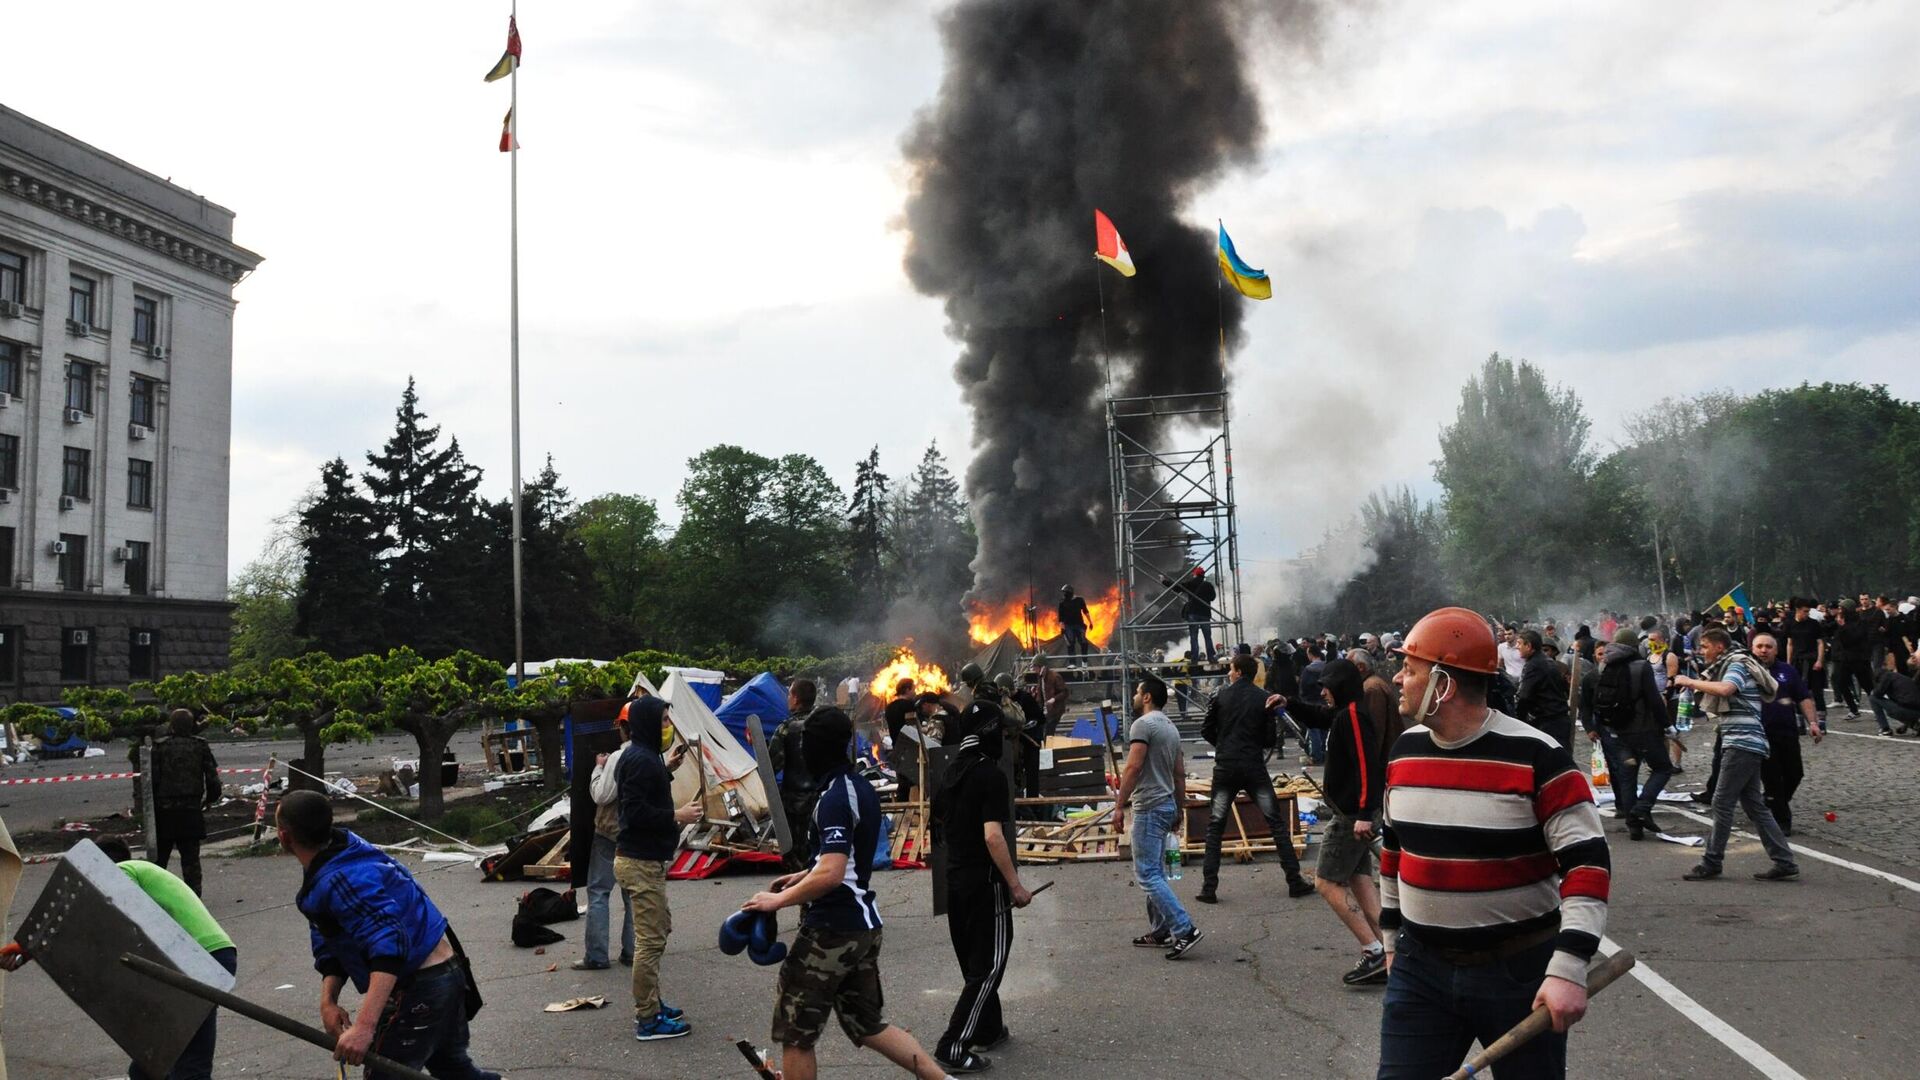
0, 0, 1920, 594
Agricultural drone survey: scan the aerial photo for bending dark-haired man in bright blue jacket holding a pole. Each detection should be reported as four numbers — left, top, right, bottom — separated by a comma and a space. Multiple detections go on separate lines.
275, 792, 499, 1080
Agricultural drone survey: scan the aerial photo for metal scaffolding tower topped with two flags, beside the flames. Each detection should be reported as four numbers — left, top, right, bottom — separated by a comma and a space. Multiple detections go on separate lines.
1106, 390, 1242, 730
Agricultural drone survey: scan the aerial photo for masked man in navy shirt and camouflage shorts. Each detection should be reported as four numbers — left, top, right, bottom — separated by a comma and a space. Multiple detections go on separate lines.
741, 707, 948, 1080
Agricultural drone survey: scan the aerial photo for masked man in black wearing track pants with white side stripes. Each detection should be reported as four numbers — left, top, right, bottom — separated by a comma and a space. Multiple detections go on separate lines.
933, 701, 1033, 1072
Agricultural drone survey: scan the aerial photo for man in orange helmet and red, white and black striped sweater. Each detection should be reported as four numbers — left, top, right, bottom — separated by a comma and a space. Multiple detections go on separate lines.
1379, 607, 1611, 1080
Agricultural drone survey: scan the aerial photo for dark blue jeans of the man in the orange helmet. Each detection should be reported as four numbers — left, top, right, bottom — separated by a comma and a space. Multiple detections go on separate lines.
1379, 932, 1567, 1080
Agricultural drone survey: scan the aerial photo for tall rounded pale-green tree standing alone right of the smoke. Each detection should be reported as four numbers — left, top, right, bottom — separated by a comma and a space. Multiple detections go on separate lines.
1434, 354, 1594, 615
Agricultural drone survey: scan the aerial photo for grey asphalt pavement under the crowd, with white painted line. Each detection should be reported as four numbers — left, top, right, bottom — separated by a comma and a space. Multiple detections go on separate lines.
0, 711, 1920, 1080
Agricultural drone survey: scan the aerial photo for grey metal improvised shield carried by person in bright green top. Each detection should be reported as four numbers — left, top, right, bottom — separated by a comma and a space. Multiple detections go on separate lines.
19, 840, 234, 1076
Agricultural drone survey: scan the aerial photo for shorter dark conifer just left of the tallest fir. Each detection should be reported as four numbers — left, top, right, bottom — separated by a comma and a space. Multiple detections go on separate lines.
294, 457, 386, 657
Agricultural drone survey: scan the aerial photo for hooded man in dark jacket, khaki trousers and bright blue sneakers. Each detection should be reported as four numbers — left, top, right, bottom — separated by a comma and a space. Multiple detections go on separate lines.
612, 696, 701, 1042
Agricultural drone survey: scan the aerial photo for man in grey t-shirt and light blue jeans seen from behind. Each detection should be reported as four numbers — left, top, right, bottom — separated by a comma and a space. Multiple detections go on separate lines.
1114, 676, 1200, 961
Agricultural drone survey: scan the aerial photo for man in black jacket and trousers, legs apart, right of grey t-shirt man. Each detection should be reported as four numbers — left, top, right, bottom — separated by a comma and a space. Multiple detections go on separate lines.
1198, 655, 1313, 903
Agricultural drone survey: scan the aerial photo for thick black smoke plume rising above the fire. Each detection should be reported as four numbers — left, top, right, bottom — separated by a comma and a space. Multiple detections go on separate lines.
904, 0, 1313, 601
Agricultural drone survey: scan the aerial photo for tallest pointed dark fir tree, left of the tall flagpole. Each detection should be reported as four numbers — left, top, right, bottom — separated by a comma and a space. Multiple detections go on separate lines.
361, 377, 483, 655
